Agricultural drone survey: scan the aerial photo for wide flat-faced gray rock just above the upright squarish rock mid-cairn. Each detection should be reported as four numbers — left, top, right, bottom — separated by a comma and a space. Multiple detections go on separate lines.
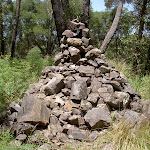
77, 65, 94, 76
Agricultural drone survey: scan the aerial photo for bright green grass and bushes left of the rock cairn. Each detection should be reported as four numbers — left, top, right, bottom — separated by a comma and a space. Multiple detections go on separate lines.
0, 52, 52, 112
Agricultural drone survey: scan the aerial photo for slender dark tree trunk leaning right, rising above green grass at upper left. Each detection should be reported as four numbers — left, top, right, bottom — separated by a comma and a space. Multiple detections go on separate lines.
10, 0, 21, 58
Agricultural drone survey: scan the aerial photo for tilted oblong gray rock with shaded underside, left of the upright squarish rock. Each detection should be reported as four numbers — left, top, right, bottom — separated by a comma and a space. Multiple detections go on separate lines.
44, 75, 64, 95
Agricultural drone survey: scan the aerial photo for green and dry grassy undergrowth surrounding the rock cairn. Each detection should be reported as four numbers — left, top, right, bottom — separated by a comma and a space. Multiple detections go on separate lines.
0, 54, 150, 150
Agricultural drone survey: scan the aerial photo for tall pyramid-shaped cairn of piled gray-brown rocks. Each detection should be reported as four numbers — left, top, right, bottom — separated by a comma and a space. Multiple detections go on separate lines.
3, 20, 150, 142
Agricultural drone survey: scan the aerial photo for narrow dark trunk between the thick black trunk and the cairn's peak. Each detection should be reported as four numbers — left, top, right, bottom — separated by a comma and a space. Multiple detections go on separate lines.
61, 0, 71, 28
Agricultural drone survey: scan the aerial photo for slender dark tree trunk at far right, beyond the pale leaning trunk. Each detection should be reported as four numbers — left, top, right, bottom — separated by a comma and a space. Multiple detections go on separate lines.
132, 0, 147, 72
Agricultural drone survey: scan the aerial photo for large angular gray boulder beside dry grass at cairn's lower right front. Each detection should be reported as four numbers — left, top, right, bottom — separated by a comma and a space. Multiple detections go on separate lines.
84, 107, 111, 129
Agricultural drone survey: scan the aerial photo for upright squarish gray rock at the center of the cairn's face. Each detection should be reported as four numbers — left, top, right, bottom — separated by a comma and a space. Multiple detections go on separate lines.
71, 81, 87, 100
